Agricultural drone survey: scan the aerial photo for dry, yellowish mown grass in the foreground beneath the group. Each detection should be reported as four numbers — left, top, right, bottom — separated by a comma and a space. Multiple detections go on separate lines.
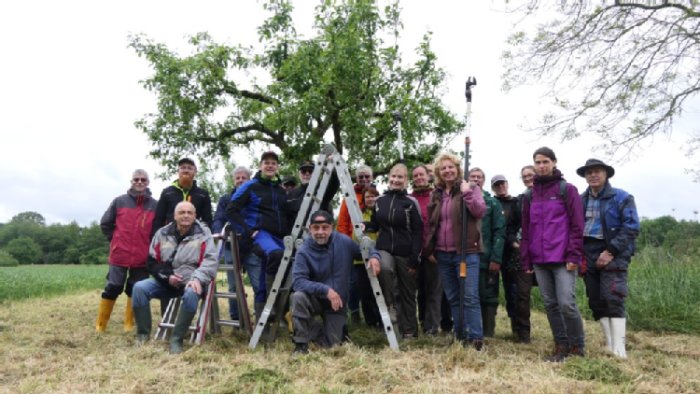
0, 291, 700, 393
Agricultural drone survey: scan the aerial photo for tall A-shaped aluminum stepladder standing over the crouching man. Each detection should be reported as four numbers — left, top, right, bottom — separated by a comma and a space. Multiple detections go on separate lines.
249, 145, 399, 350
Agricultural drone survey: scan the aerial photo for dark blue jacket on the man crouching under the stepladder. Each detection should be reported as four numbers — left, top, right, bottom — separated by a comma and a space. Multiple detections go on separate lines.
292, 231, 381, 308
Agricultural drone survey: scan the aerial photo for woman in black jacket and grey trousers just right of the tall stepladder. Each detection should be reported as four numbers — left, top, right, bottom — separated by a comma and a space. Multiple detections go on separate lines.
368, 164, 423, 339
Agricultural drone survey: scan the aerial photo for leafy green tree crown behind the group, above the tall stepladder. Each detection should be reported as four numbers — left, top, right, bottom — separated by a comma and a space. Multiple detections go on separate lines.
130, 0, 462, 174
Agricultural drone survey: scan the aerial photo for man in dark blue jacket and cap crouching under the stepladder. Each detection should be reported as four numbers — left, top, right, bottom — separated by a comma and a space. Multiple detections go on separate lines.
291, 210, 381, 354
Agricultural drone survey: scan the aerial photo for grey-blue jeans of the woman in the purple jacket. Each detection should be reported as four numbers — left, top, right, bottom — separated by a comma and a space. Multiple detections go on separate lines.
534, 263, 584, 348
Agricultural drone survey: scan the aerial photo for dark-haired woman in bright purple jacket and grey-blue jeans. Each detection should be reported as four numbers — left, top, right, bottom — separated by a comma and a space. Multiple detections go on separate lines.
520, 147, 584, 362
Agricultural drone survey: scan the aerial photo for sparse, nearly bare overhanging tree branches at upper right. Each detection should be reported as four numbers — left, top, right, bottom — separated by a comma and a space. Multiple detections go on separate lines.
504, 0, 700, 159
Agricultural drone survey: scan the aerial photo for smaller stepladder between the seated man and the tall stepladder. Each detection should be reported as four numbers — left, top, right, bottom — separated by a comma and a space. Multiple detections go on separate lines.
209, 223, 253, 336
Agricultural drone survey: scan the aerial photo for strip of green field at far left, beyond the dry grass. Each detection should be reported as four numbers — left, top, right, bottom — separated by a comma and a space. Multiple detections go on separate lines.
0, 265, 107, 303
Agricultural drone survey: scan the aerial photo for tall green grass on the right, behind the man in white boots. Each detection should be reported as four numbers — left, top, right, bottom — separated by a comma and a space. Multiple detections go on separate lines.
524, 248, 700, 335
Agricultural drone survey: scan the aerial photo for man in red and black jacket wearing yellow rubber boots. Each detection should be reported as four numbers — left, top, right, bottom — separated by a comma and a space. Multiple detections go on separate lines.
95, 170, 158, 332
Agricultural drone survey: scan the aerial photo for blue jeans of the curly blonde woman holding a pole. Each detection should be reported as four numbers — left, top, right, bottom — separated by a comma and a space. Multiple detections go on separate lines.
435, 252, 484, 340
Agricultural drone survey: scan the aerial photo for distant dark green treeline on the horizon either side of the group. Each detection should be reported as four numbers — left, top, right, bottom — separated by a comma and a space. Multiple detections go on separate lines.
0, 212, 700, 266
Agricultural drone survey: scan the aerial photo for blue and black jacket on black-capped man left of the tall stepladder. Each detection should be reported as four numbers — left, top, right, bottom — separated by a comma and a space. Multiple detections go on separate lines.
226, 171, 290, 239
